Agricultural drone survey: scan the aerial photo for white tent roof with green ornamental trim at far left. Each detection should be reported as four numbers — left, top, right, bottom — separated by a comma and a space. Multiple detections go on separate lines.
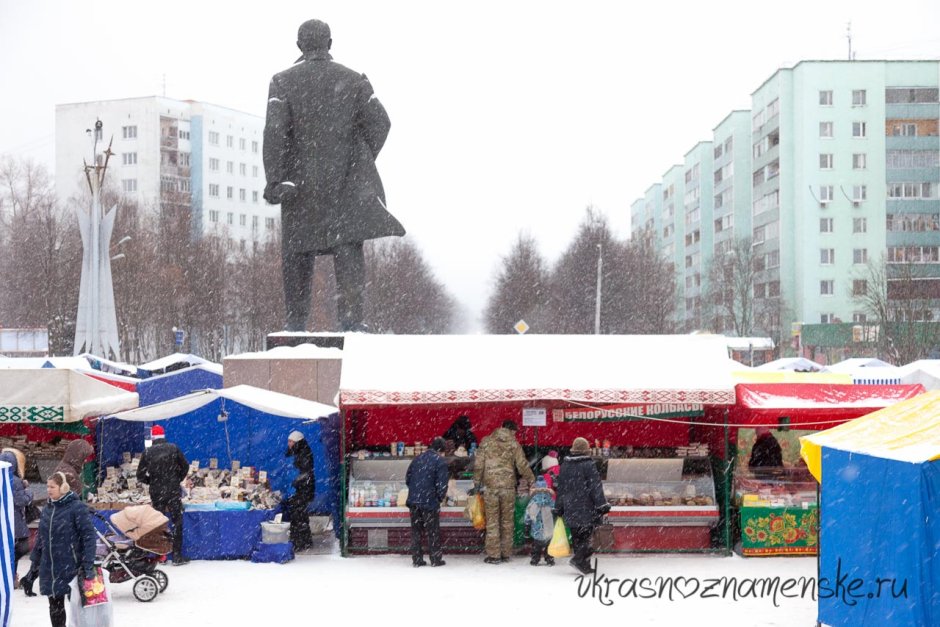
0, 368, 138, 424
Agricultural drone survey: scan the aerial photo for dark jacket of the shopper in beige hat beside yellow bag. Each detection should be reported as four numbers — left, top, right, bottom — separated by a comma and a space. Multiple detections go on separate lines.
555, 455, 610, 527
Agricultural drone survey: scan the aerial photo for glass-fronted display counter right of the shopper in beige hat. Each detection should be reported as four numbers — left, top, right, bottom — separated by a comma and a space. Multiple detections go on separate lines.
595, 457, 719, 551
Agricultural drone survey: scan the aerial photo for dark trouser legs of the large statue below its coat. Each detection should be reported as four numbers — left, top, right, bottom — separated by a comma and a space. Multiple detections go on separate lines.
281, 242, 366, 331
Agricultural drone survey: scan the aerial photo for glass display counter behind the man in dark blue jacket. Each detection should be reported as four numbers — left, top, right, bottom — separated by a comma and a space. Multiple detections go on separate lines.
346, 457, 483, 553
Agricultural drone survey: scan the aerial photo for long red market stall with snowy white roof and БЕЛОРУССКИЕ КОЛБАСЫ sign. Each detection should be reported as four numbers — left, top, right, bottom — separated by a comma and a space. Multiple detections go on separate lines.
340, 335, 734, 553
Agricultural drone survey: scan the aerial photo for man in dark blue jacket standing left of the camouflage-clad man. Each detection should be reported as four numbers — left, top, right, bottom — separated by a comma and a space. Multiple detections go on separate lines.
405, 438, 448, 568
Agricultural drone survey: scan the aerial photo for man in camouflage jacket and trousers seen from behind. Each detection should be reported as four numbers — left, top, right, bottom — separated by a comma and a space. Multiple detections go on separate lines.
473, 420, 535, 564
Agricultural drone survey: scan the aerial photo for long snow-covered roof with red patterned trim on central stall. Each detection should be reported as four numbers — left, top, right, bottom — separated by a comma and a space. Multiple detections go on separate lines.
340, 333, 734, 406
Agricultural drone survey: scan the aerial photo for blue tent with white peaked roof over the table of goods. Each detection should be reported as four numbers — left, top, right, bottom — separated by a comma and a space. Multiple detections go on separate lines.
97, 385, 340, 530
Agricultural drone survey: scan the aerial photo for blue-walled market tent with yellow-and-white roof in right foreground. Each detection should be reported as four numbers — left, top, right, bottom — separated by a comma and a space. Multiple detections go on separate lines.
801, 391, 940, 626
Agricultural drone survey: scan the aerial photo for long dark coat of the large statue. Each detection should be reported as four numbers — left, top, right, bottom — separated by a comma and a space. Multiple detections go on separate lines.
263, 50, 405, 254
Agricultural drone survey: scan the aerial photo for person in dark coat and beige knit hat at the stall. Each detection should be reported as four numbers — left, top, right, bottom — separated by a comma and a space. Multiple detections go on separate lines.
555, 438, 610, 575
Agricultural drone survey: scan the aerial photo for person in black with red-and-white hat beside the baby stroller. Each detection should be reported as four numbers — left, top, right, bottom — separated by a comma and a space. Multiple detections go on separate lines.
137, 425, 189, 566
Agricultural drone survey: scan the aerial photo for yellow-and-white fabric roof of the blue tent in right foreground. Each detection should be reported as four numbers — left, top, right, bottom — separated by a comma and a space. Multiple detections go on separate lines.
800, 390, 940, 482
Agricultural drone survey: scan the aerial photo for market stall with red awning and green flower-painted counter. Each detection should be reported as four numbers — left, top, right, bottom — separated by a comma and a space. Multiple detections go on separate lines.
711, 383, 923, 556
